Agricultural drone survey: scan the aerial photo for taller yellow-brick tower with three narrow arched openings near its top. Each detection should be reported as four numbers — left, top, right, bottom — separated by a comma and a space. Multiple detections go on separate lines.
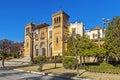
52, 11, 69, 56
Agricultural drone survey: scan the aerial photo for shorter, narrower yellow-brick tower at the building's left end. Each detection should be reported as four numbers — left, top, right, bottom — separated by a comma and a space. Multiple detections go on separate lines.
24, 23, 35, 57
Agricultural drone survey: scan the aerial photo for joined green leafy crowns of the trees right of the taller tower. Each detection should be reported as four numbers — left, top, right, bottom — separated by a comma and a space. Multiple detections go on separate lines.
65, 35, 96, 56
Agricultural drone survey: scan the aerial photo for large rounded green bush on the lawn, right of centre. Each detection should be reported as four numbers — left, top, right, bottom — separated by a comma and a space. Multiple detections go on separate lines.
63, 57, 77, 69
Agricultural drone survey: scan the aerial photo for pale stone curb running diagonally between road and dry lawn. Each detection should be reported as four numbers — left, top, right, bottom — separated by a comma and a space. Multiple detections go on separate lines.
13, 69, 91, 80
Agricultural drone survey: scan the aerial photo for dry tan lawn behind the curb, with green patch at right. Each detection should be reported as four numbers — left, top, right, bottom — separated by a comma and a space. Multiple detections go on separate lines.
18, 63, 120, 80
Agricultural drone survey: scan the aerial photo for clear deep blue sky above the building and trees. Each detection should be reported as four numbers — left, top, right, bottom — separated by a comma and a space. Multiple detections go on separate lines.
0, 0, 120, 42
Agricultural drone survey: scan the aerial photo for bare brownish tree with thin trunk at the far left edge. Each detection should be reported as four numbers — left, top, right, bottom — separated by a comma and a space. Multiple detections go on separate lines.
0, 39, 12, 67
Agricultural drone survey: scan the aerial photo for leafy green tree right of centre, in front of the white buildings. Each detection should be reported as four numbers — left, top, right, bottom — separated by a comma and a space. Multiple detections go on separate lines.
78, 36, 95, 65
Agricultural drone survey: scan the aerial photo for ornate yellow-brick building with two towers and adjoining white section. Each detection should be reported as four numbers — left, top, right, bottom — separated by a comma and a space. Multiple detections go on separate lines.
24, 11, 84, 56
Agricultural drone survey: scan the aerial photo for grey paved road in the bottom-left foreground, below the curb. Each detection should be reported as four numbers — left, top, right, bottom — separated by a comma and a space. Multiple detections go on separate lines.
0, 69, 69, 80
